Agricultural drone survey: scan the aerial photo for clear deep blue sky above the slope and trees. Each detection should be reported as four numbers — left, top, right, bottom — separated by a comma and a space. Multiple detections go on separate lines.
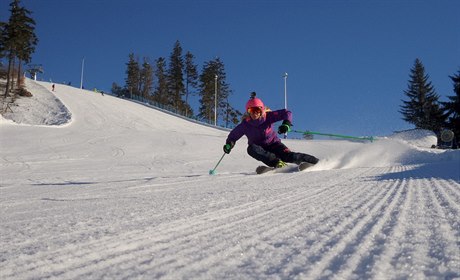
0, 0, 460, 135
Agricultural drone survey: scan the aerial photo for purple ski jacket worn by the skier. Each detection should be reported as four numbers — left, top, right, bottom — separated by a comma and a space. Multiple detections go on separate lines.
226, 109, 292, 147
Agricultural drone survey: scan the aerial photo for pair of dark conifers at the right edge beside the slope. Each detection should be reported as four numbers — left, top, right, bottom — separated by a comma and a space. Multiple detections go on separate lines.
399, 58, 460, 148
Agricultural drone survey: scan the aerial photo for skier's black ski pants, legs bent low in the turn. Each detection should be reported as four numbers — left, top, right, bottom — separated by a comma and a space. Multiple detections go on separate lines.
247, 142, 319, 167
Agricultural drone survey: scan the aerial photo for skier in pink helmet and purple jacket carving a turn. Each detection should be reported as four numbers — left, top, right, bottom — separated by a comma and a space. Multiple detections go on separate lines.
224, 92, 319, 168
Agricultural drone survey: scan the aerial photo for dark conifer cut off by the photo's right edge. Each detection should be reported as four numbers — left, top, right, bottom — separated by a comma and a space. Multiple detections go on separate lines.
441, 70, 460, 147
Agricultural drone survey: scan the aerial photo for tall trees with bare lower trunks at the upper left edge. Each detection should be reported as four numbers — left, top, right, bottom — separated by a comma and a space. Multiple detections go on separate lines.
0, 0, 38, 96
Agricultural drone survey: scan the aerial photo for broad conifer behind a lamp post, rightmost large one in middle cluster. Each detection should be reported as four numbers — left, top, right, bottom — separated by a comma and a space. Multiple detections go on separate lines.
198, 58, 232, 123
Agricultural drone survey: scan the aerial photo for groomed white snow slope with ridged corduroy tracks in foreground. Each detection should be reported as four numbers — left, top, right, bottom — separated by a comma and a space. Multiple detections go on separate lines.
0, 80, 460, 279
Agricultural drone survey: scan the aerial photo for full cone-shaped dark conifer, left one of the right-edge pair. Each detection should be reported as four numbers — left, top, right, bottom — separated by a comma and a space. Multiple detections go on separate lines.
399, 58, 445, 134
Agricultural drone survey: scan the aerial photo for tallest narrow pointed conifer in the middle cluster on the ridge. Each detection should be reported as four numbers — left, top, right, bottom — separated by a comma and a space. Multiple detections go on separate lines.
167, 41, 186, 112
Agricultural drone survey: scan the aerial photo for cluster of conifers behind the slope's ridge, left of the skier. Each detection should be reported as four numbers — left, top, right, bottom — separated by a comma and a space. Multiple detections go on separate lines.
112, 40, 242, 127
